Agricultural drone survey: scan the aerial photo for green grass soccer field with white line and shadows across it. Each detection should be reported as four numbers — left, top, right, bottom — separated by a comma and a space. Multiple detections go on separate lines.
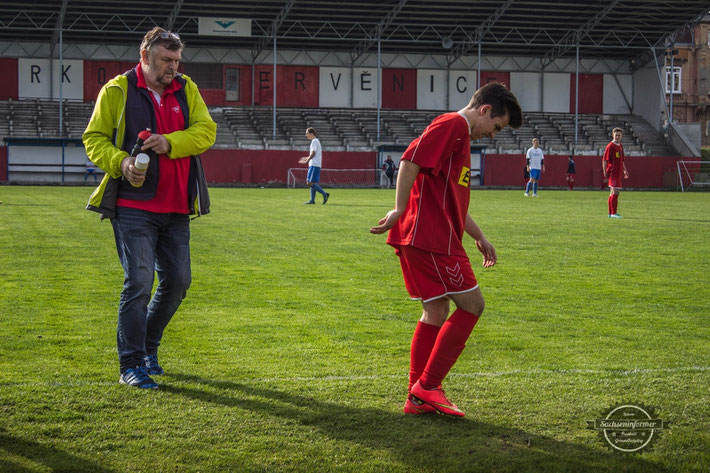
0, 186, 710, 472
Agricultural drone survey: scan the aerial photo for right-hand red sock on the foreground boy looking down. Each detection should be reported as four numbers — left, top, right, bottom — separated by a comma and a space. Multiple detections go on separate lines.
419, 309, 478, 389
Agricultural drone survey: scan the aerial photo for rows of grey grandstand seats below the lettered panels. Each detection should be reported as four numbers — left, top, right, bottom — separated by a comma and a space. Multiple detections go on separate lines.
0, 100, 676, 156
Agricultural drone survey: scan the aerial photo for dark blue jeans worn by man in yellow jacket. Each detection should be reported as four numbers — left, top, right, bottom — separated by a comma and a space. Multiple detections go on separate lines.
111, 207, 191, 372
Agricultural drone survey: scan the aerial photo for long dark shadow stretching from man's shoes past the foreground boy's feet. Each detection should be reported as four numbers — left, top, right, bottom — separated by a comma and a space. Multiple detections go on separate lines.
161, 374, 669, 472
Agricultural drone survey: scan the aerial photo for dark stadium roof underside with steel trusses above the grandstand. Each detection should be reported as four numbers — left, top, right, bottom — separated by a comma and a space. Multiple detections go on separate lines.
0, 0, 710, 62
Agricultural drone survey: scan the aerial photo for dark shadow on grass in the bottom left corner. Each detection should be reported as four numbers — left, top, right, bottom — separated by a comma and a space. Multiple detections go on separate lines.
0, 432, 113, 473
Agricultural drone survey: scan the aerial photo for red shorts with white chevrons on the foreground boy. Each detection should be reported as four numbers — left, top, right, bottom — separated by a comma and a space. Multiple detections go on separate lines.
396, 246, 478, 302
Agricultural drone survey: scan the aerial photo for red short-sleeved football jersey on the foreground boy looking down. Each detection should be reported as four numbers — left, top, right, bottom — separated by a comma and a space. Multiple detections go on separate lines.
387, 112, 471, 255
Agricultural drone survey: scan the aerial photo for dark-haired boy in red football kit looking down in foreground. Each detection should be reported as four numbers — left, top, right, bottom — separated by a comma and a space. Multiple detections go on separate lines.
370, 82, 523, 416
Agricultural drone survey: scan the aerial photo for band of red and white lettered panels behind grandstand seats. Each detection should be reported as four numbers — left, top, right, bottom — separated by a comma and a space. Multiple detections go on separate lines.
0, 58, 633, 113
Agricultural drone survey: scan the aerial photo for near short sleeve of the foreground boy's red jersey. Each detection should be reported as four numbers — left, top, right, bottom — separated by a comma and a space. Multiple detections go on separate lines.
402, 117, 466, 175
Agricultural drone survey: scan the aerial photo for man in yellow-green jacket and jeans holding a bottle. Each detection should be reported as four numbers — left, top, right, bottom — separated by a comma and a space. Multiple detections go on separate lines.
83, 27, 217, 389
